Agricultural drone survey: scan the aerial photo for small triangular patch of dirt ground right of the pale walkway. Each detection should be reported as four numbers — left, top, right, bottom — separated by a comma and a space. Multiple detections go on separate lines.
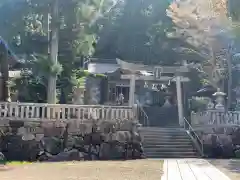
209, 159, 240, 180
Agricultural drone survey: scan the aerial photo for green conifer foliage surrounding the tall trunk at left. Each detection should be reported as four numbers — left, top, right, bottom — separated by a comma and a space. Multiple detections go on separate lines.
0, 0, 114, 101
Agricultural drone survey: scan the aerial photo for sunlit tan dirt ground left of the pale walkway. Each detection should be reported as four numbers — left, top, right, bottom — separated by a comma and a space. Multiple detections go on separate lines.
0, 160, 163, 180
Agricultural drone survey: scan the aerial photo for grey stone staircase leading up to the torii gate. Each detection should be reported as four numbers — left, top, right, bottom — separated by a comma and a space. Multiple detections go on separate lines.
140, 127, 199, 158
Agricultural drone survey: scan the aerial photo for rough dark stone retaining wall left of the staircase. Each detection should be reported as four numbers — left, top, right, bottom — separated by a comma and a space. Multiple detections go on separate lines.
0, 120, 143, 161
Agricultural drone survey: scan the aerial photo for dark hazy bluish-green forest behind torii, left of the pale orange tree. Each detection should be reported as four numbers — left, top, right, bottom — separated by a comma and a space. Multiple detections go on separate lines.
95, 0, 181, 65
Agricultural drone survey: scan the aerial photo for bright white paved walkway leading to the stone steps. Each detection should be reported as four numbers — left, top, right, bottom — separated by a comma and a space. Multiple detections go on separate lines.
161, 159, 231, 180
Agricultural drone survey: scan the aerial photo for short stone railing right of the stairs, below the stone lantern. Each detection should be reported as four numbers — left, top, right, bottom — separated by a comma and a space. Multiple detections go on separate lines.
191, 110, 240, 126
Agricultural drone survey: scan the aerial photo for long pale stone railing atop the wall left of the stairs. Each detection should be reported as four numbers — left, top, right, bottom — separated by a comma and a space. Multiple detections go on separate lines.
0, 102, 137, 121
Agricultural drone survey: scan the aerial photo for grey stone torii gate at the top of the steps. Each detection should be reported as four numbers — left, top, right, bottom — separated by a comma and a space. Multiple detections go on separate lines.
117, 59, 190, 126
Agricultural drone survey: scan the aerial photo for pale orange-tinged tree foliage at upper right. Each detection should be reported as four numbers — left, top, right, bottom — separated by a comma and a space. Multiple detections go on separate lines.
167, 0, 232, 91
